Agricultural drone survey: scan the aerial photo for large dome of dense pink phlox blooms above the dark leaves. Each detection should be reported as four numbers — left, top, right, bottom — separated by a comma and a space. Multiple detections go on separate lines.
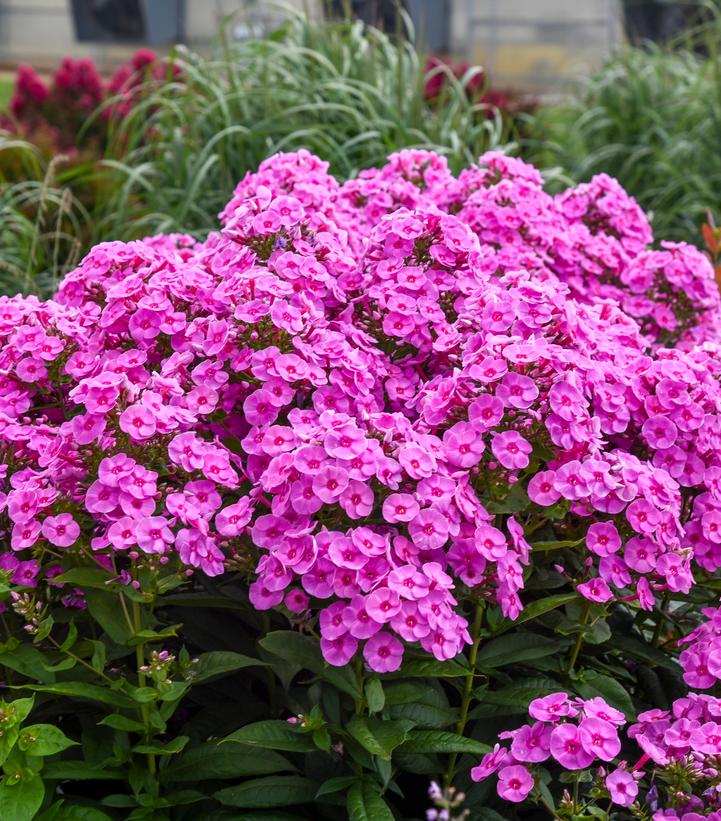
0, 151, 721, 692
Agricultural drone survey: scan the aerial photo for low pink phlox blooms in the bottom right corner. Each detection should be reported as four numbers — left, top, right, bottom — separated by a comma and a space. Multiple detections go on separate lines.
471, 692, 721, 821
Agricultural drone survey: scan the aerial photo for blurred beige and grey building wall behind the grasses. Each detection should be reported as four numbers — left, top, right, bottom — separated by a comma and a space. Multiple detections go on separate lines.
0, 0, 708, 91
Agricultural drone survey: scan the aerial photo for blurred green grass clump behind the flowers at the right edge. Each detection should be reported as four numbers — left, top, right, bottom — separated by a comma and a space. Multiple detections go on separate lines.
526, 21, 721, 243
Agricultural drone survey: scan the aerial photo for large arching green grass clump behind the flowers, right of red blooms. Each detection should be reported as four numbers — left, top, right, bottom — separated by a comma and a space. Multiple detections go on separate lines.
91, 8, 504, 238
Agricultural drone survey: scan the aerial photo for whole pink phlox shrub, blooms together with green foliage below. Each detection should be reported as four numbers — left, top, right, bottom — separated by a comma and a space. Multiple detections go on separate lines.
0, 151, 721, 821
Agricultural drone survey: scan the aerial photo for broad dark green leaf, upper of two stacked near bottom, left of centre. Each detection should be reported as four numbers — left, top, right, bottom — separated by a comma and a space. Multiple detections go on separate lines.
160, 742, 295, 784
